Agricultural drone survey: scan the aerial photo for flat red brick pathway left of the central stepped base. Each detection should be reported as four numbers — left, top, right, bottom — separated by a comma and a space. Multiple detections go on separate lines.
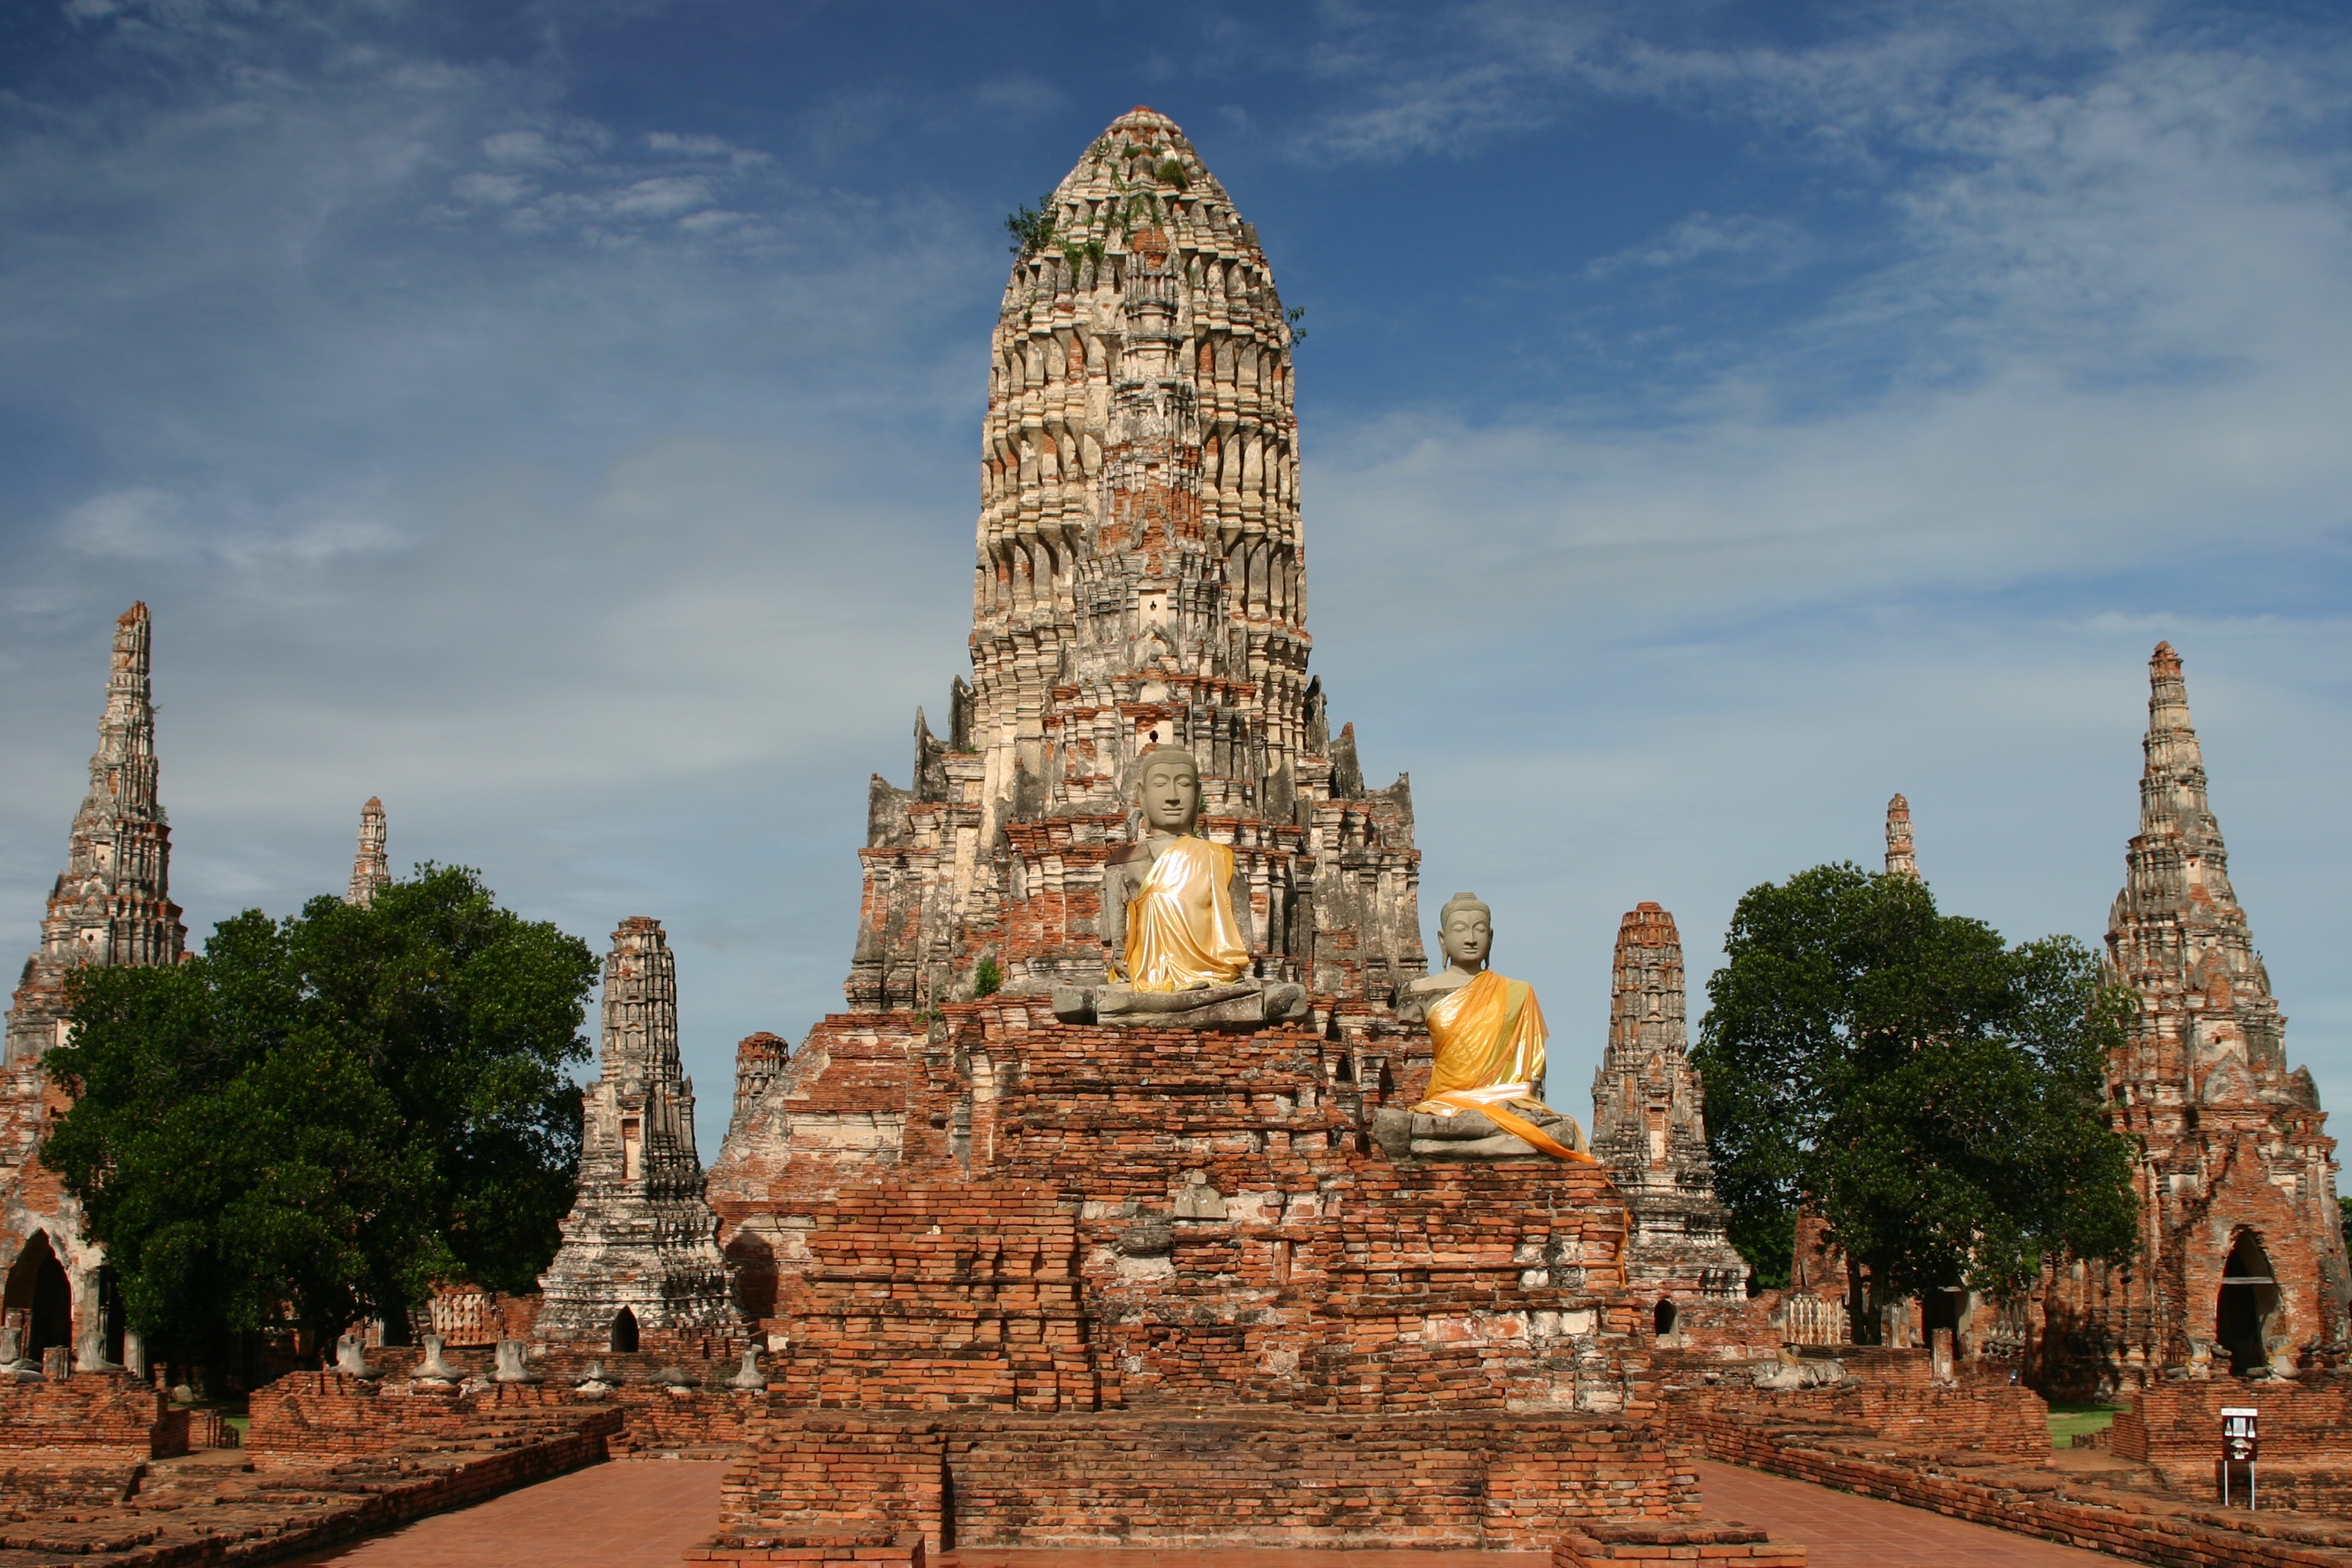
275, 1460, 727, 1568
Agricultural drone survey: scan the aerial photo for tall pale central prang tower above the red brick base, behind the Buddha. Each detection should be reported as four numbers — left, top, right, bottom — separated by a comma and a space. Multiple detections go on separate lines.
849, 108, 1426, 1008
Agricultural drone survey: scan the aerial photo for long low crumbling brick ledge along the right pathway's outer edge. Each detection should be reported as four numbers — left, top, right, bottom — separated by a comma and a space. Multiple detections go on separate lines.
1677, 1408, 2352, 1568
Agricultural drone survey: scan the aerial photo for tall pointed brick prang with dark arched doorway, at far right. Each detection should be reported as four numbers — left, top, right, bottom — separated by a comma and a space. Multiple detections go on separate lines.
2041, 642, 2352, 1387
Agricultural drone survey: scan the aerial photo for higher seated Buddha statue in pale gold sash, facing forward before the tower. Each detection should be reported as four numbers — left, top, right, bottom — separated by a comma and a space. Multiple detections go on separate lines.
1054, 745, 1305, 1027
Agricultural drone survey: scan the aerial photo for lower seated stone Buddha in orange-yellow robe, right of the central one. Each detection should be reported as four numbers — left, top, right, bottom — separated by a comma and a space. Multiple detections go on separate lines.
1371, 893, 1592, 1164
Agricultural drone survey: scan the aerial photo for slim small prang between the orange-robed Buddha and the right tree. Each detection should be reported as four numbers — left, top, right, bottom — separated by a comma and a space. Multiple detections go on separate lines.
1592, 903, 1747, 1326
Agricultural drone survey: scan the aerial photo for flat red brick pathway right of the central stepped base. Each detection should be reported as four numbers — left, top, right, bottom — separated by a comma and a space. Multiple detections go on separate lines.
1698, 1460, 2115, 1568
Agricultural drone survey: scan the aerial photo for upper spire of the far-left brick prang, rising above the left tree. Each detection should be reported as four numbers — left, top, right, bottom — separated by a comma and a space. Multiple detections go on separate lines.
7, 604, 188, 1063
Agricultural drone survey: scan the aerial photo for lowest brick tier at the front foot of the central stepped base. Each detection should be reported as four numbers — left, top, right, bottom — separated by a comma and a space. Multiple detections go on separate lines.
713, 1408, 1698, 1552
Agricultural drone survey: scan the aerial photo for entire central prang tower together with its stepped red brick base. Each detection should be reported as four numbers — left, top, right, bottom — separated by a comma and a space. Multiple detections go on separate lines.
708, 108, 1696, 1547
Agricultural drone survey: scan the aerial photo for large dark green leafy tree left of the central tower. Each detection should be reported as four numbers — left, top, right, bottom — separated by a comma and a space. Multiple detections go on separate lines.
42, 865, 597, 1354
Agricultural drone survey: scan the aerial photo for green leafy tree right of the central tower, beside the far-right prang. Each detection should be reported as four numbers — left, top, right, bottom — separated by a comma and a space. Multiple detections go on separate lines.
1694, 865, 2138, 1342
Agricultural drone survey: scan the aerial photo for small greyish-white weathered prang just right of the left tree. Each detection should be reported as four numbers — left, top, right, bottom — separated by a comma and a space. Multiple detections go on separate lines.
534, 914, 739, 1349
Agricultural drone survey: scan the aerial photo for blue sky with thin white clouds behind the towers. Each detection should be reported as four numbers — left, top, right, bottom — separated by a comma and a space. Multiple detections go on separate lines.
0, 0, 2352, 1128
